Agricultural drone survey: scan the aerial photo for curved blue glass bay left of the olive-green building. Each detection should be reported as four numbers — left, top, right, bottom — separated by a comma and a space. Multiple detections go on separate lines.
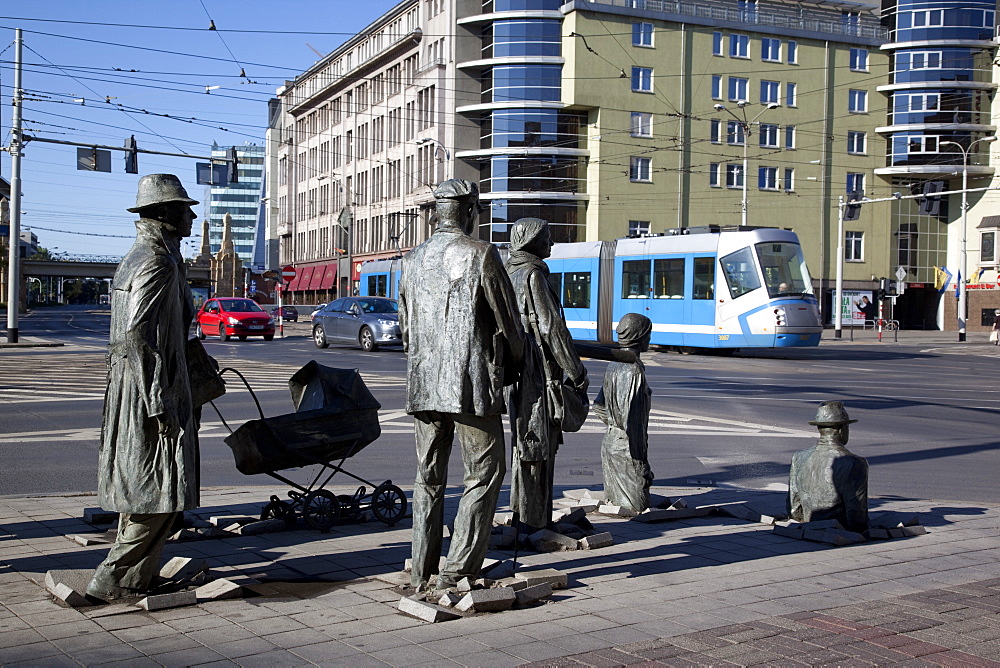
468, 0, 587, 243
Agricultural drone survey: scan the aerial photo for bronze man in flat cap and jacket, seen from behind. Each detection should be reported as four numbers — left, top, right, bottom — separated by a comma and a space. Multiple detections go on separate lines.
399, 179, 524, 589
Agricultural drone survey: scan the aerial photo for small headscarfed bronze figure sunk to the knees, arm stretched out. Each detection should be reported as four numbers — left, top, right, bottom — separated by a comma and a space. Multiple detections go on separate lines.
594, 313, 653, 513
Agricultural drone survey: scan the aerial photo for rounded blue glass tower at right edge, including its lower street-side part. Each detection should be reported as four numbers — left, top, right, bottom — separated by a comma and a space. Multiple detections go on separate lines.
875, 0, 997, 327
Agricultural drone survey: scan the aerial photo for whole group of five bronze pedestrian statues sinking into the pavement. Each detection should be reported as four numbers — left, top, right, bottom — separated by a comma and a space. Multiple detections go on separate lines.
87, 174, 867, 601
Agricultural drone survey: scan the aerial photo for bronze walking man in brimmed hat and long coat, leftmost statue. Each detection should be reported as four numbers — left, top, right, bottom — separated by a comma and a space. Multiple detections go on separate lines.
87, 174, 206, 601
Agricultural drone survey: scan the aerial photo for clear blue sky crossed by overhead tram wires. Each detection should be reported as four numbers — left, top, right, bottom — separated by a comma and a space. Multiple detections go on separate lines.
0, 0, 396, 255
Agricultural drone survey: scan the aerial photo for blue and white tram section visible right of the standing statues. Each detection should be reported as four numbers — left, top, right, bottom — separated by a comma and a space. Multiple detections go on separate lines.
547, 227, 823, 348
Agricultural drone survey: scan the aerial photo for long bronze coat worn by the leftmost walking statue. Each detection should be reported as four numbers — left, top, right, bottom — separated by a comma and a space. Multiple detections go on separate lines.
98, 219, 198, 513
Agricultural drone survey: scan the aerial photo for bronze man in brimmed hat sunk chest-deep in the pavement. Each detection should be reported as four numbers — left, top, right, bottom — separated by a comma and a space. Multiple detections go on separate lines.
788, 401, 868, 532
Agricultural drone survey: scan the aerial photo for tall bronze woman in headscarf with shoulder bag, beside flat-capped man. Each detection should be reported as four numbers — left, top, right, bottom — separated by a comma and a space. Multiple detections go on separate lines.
507, 218, 589, 528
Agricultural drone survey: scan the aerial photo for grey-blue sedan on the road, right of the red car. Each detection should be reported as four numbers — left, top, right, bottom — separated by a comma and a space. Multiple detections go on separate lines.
313, 297, 403, 352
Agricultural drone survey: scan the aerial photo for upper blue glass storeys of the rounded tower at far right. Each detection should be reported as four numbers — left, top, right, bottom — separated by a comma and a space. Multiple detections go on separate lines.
886, 0, 996, 167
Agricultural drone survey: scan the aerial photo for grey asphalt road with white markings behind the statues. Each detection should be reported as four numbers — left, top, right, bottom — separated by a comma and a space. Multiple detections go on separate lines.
0, 307, 1000, 504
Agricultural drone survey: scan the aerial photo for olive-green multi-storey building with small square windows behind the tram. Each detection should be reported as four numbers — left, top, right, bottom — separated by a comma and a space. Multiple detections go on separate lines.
562, 0, 895, 314
